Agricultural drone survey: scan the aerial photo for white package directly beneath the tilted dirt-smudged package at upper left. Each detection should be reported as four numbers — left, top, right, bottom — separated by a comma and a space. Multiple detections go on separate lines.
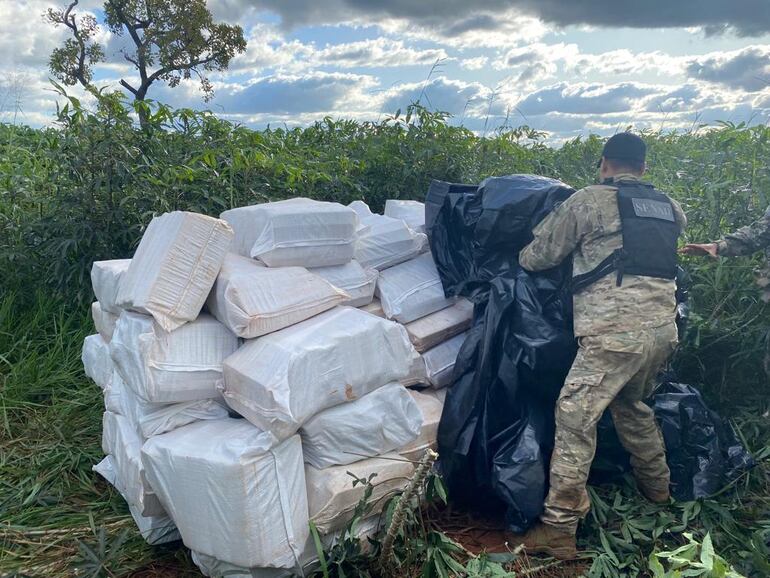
110, 311, 238, 403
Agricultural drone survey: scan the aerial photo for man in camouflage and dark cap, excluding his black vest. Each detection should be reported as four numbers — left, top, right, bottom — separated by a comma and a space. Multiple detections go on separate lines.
519, 133, 686, 558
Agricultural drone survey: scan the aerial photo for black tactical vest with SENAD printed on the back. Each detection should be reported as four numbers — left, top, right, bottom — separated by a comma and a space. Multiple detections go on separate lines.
572, 181, 681, 294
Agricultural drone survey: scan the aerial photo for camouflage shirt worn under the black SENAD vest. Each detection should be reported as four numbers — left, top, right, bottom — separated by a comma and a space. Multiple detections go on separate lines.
519, 175, 687, 336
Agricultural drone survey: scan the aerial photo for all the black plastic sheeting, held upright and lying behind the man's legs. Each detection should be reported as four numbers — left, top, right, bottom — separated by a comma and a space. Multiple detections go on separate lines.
426, 175, 751, 531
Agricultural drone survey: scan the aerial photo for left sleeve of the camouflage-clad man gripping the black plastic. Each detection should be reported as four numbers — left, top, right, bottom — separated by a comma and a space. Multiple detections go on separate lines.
519, 190, 592, 271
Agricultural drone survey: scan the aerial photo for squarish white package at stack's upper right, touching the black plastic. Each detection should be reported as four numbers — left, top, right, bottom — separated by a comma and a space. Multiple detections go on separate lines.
377, 253, 454, 323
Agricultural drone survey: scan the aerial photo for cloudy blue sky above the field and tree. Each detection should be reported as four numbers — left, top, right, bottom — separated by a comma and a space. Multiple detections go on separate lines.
0, 0, 770, 142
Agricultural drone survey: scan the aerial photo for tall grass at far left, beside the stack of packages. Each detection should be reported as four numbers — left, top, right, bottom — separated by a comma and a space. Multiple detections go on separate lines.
0, 292, 196, 576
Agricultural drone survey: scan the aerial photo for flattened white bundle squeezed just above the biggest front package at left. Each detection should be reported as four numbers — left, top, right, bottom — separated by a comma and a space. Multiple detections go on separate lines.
104, 371, 229, 440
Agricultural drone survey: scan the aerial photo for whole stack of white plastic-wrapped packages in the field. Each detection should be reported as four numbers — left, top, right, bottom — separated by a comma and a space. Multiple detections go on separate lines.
83, 199, 464, 578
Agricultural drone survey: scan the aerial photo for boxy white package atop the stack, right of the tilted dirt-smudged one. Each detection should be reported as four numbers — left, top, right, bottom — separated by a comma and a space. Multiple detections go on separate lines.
220, 198, 358, 267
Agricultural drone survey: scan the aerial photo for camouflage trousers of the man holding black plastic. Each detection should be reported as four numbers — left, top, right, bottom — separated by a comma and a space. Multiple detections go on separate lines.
541, 323, 677, 533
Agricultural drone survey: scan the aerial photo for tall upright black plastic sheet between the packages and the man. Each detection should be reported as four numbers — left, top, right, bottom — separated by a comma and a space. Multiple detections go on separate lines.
426, 175, 576, 531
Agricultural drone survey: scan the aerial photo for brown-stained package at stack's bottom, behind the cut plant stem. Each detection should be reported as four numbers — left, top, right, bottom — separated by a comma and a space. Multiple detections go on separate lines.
305, 453, 414, 534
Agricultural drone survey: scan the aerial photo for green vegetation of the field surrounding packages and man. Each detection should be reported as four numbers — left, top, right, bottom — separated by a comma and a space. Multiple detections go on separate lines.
0, 100, 770, 577
